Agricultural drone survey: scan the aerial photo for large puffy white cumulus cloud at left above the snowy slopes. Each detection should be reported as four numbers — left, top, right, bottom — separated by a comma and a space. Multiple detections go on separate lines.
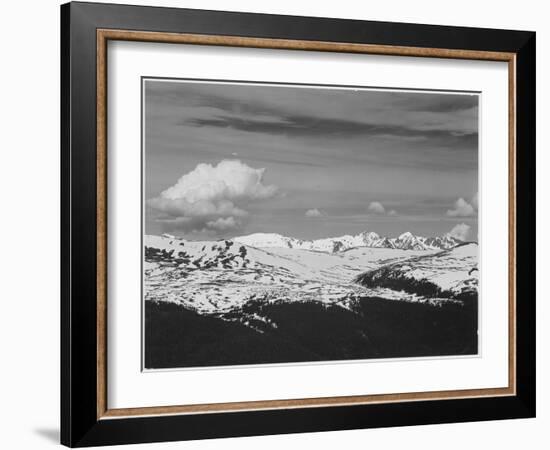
147, 160, 278, 232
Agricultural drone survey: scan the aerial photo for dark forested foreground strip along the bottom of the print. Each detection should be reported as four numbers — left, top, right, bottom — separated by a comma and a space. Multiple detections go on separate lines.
145, 298, 478, 369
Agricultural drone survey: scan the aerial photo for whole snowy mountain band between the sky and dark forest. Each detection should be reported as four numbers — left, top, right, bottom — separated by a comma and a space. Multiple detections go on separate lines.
143, 232, 477, 314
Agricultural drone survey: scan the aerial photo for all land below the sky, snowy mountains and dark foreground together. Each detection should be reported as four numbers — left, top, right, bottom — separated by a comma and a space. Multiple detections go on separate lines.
143, 232, 478, 369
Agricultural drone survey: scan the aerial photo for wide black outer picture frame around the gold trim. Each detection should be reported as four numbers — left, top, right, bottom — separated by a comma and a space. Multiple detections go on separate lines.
61, 2, 536, 447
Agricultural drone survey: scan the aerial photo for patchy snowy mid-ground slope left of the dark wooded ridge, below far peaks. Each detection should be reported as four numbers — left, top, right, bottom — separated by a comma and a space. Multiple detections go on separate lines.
144, 236, 444, 313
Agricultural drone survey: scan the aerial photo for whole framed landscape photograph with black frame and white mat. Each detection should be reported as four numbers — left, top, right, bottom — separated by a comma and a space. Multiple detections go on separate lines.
61, 3, 536, 447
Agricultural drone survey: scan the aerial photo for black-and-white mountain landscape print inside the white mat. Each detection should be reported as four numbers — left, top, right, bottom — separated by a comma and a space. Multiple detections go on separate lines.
142, 78, 479, 370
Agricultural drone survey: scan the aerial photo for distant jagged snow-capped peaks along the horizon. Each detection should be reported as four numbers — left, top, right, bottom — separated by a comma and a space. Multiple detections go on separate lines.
233, 231, 462, 253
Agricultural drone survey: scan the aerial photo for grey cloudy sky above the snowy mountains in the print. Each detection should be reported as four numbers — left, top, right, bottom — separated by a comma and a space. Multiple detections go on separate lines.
143, 79, 478, 240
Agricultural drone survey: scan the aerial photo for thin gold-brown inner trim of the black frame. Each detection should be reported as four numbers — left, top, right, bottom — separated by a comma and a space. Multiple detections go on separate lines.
96, 29, 516, 420
